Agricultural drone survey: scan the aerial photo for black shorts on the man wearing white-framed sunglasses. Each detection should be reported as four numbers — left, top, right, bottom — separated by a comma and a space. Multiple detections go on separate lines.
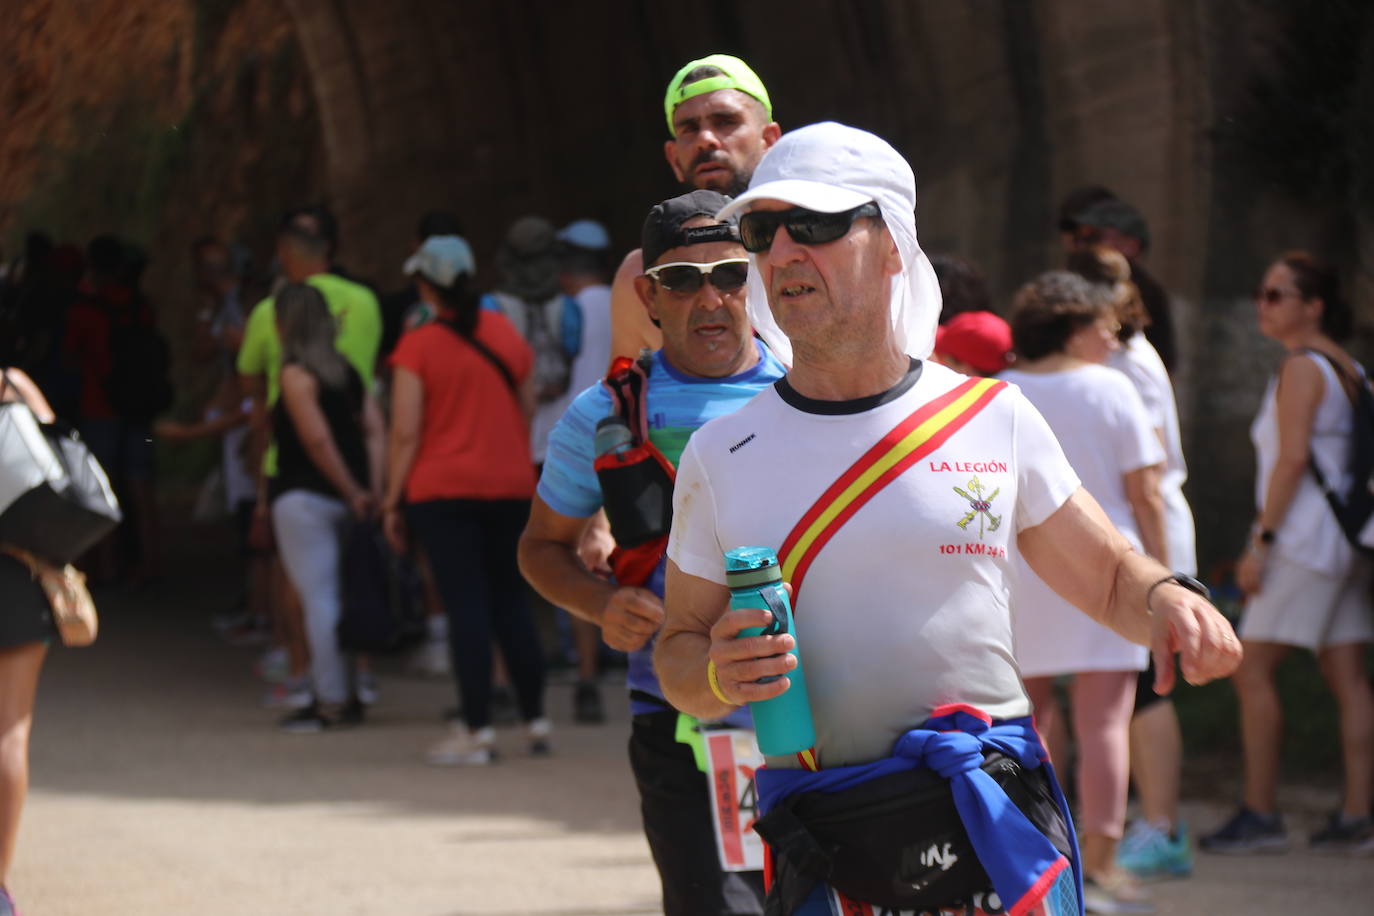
629, 710, 764, 916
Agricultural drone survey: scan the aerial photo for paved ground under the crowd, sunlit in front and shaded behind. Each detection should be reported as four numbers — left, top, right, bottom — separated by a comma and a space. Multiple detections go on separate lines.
11, 531, 1374, 916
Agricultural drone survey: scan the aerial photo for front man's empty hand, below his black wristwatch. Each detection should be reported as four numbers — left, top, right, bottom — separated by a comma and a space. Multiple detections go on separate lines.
1150, 582, 1241, 696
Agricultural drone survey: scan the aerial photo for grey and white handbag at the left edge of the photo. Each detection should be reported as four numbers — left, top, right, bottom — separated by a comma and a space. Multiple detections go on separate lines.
0, 374, 122, 566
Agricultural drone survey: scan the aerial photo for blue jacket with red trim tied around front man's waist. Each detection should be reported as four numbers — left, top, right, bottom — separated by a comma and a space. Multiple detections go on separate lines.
756, 706, 1083, 916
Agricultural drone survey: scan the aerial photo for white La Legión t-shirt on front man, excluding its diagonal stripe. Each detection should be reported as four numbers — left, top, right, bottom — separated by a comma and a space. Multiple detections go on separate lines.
668, 363, 1079, 768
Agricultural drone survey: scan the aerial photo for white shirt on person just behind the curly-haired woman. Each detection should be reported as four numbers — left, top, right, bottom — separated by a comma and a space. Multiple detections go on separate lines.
1107, 334, 1198, 575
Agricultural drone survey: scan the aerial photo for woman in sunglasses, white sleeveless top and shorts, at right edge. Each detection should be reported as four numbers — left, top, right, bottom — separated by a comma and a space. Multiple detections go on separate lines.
1201, 251, 1374, 854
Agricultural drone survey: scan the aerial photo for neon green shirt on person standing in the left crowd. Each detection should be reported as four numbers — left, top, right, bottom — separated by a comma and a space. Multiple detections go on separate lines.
238, 273, 382, 477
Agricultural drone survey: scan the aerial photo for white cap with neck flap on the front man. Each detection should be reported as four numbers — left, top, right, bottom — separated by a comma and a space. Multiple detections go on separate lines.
717, 121, 941, 365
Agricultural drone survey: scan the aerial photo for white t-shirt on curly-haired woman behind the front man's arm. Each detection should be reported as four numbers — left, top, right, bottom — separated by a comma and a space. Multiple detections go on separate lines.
999, 365, 1164, 677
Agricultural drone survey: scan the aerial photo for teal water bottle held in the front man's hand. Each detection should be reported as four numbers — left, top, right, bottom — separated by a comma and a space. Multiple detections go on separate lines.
725, 547, 816, 757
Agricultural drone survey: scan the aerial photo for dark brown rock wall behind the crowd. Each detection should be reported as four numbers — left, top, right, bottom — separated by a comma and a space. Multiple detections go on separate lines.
0, 0, 1374, 571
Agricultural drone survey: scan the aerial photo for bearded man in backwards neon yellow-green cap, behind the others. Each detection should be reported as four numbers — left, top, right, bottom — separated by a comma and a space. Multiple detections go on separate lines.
610, 54, 782, 358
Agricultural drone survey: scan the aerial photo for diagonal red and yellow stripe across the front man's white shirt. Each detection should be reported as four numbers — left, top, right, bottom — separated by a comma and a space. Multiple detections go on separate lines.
778, 379, 1007, 770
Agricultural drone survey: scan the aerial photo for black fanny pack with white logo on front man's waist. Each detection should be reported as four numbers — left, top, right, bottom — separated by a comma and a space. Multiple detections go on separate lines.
754, 753, 1072, 916
